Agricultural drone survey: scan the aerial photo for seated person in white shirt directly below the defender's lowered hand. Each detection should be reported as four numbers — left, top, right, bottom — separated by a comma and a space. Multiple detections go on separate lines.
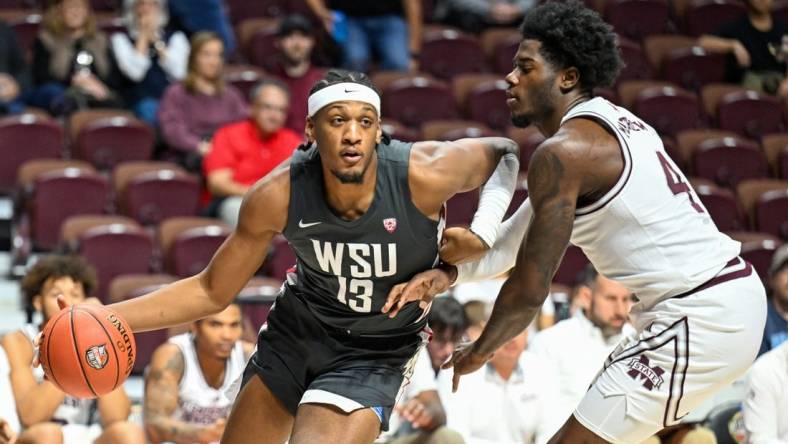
445, 322, 561, 444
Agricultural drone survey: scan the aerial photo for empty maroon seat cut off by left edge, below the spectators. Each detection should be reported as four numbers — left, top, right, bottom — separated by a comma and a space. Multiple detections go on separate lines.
0, 114, 63, 193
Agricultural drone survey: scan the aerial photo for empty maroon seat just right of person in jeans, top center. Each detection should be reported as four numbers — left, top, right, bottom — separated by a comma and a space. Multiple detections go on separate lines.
419, 29, 488, 79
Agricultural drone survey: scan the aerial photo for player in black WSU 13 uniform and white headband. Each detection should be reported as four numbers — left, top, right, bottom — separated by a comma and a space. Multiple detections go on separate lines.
74, 71, 518, 444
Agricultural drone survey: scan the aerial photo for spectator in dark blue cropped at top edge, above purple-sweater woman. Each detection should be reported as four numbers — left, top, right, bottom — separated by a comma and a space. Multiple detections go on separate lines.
169, 0, 235, 57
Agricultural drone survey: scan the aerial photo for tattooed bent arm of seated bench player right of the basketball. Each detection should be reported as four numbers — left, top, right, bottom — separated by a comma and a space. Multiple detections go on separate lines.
143, 344, 219, 443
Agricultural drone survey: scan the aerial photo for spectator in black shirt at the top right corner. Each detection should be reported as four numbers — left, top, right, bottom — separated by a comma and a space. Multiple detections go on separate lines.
698, 0, 788, 100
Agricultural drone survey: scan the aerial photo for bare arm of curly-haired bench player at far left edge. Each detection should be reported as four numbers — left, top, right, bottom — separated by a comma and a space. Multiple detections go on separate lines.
3, 331, 66, 427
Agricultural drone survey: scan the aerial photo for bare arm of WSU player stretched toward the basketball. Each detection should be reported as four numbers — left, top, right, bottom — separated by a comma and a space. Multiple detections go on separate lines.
109, 162, 290, 331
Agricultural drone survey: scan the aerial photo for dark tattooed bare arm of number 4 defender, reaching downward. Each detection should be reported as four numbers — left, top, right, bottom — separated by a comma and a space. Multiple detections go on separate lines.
447, 139, 585, 389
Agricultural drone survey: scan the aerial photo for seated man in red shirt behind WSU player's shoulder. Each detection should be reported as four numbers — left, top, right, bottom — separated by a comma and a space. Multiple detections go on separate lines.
203, 79, 302, 227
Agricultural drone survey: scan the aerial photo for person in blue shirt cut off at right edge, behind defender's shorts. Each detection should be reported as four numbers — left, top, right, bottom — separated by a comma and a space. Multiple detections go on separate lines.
758, 244, 788, 355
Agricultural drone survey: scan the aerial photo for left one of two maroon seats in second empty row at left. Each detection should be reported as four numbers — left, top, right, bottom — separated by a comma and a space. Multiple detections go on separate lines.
29, 168, 109, 250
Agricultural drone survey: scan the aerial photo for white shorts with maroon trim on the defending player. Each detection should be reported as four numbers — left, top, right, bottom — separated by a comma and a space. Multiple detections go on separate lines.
574, 258, 766, 443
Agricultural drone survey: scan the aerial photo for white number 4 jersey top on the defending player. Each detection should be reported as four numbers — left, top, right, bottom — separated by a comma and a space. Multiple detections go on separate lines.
561, 97, 741, 306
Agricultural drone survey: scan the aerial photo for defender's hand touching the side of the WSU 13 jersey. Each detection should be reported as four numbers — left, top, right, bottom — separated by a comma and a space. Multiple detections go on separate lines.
380, 268, 452, 318
